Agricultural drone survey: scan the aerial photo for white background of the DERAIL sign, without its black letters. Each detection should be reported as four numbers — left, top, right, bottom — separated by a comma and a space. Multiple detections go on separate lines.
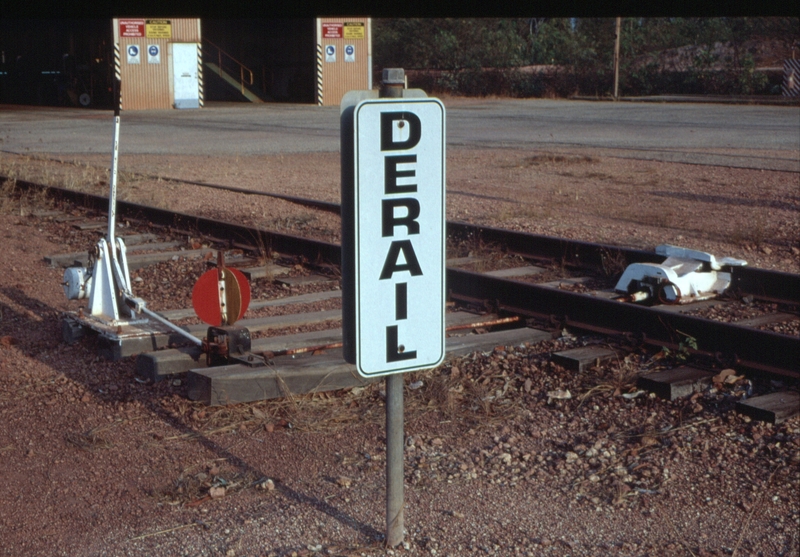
353, 98, 446, 377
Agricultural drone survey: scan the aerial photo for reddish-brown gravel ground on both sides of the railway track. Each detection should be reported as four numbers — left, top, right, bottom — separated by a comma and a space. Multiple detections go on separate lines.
0, 130, 800, 557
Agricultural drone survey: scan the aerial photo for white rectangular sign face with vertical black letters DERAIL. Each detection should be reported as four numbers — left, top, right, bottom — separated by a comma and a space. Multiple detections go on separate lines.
343, 98, 446, 377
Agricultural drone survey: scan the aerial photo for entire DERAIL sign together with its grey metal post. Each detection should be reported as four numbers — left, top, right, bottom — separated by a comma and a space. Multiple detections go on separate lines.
341, 69, 445, 547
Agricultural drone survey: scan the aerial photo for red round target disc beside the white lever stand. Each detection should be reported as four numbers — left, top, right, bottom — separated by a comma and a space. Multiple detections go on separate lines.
192, 267, 250, 327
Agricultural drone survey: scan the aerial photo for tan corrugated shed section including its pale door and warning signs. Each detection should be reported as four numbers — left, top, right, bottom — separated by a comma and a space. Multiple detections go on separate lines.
112, 18, 203, 110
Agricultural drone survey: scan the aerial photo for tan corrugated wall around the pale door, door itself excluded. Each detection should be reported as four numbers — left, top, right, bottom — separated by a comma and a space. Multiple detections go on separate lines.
112, 18, 202, 110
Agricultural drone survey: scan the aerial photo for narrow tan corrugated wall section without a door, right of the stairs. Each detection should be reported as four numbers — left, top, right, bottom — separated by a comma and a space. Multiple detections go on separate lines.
317, 17, 372, 106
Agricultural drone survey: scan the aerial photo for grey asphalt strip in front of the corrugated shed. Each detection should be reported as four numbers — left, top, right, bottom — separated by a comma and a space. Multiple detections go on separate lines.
0, 99, 800, 172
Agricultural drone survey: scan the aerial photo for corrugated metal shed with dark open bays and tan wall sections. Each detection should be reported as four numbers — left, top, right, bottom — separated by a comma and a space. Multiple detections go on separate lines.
0, 16, 373, 110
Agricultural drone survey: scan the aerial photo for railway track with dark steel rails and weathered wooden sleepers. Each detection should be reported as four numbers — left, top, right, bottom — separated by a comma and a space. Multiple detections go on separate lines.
6, 176, 800, 418
